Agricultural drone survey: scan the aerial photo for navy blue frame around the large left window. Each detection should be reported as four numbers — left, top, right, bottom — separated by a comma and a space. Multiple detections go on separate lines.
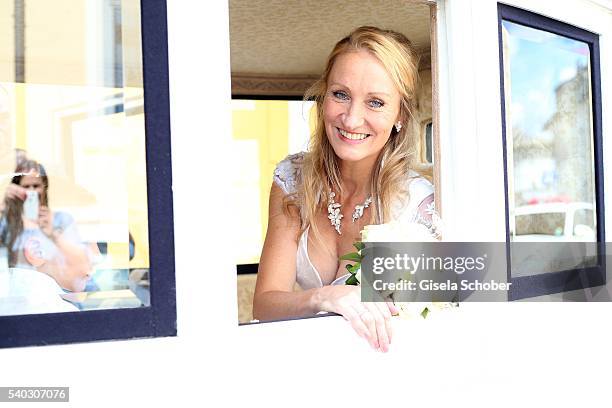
0, 0, 177, 347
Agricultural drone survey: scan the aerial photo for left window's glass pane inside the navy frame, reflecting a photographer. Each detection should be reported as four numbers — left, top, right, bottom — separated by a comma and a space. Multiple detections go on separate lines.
0, 0, 149, 315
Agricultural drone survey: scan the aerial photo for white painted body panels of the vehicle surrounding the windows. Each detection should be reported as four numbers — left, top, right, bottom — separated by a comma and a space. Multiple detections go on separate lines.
0, 0, 612, 407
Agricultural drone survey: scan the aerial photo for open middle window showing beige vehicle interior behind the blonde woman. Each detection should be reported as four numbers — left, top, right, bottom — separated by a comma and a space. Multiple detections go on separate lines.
229, 0, 438, 322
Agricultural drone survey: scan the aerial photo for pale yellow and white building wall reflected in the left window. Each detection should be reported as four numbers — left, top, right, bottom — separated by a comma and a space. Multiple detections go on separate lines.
0, 0, 148, 267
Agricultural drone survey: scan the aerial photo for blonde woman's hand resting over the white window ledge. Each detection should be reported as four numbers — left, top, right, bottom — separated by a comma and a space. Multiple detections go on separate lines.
319, 285, 398, 352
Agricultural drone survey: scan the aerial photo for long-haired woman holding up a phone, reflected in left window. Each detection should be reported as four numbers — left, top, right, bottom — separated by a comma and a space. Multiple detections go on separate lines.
0, 159, 91, 292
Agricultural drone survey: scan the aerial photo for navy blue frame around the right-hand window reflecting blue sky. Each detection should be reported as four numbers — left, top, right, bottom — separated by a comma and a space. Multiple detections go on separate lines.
497, 3, 606, 300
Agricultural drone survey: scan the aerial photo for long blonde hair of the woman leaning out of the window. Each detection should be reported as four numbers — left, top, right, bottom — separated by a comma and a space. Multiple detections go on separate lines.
285, 26, 418, 244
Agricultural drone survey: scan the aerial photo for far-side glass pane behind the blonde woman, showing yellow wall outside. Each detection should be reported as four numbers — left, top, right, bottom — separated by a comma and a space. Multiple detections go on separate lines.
232, 99, 314, 265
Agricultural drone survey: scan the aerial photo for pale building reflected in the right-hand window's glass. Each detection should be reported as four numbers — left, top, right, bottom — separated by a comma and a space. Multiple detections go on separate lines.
512, 66, 594, 206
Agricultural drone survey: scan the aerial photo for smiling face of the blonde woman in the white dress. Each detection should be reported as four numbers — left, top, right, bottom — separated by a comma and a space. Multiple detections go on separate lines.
323, 50, 400, 162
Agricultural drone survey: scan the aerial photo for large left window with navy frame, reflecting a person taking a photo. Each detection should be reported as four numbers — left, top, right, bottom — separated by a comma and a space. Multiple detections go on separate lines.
0, 0, 176, 346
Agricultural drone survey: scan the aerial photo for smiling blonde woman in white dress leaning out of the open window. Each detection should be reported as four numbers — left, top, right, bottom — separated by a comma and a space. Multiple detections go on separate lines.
253, 27, 433, 352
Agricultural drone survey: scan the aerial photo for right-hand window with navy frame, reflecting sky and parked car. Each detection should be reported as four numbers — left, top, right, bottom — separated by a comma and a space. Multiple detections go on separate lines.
498, 5, 605, 299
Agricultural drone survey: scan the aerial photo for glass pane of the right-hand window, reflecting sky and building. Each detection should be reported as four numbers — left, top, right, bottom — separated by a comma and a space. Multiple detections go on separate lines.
502, 21, 597, 276
